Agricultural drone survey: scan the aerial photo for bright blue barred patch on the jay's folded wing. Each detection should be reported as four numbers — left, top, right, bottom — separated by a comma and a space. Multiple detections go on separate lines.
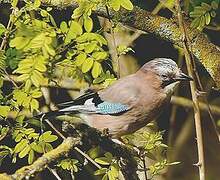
96, 101, 129, 114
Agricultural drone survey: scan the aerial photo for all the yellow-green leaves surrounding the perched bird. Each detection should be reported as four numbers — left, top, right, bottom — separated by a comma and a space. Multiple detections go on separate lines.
0, 0, 219, 180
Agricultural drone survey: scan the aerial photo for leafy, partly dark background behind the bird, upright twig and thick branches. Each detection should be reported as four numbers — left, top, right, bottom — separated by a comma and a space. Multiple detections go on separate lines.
0, 0, 220, 180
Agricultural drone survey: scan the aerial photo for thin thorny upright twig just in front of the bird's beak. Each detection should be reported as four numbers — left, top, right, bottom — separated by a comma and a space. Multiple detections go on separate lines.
176, 0, 205, 180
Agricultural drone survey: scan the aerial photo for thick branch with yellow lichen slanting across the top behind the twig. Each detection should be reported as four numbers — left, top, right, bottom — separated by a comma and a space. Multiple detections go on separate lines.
34, 0, 220, 88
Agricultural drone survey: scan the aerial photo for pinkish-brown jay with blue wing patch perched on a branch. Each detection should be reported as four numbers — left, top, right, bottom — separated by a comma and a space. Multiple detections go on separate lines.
37, 58, 193, 138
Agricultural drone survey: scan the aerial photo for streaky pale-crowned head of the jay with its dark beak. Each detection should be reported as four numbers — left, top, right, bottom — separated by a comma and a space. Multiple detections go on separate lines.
141, 58, 193, 93
